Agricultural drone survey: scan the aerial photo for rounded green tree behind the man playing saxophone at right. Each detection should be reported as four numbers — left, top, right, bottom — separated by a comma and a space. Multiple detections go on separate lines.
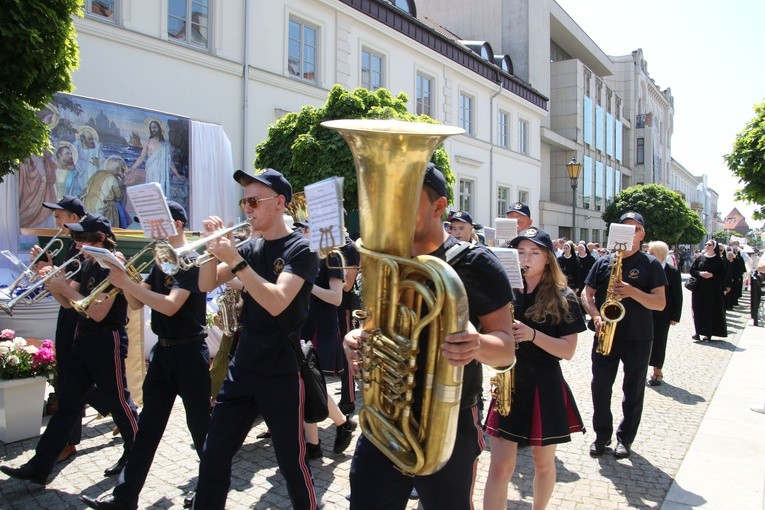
603, 184, 705, 245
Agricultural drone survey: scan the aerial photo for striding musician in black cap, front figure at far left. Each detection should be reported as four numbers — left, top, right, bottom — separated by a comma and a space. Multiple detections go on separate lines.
0, 215, 138, 485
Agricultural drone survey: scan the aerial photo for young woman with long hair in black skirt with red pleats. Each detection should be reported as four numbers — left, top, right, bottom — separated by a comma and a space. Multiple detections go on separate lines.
483, 227, 586, 510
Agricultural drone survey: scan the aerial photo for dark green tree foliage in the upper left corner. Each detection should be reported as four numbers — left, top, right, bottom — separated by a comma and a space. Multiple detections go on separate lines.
0, 0, 82, 181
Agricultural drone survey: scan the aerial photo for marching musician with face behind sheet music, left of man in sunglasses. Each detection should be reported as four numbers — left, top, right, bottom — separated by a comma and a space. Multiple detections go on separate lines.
82, 201, 210, 509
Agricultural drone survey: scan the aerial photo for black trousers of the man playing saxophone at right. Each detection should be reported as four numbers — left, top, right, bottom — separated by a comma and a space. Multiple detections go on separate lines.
591, 335, 651, 444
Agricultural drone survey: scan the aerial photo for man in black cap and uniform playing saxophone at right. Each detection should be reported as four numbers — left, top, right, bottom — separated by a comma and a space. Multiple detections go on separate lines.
582, 211, 667, 459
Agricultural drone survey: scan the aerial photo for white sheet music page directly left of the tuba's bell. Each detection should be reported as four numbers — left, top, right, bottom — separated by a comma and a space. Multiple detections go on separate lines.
304, 177, 345, 252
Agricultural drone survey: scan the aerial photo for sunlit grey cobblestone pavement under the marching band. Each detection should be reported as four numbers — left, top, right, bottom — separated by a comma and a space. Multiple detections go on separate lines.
0, 282, 748, 510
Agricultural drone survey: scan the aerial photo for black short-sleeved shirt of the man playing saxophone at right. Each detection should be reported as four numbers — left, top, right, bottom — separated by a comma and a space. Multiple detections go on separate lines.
585, 251, 667, 342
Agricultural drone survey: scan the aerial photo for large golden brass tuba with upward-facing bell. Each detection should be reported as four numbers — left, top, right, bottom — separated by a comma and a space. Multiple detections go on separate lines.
322, 120, 468, 475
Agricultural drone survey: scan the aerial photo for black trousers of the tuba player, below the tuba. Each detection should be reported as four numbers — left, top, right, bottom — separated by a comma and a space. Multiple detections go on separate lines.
351, 405, 484, 510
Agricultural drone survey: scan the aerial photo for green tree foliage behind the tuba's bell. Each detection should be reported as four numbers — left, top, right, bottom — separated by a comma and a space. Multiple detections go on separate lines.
254, 85, 454, 210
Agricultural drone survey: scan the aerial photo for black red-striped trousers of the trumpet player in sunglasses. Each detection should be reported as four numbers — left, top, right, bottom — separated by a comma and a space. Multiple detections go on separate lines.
194, 363, 317, 510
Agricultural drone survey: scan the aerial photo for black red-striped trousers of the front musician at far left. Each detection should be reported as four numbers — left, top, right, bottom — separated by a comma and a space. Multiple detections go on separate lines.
29, 329, 138, 473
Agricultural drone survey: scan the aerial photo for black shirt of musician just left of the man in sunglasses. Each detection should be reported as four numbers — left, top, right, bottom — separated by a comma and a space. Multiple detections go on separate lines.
144, 253, 207, 338
